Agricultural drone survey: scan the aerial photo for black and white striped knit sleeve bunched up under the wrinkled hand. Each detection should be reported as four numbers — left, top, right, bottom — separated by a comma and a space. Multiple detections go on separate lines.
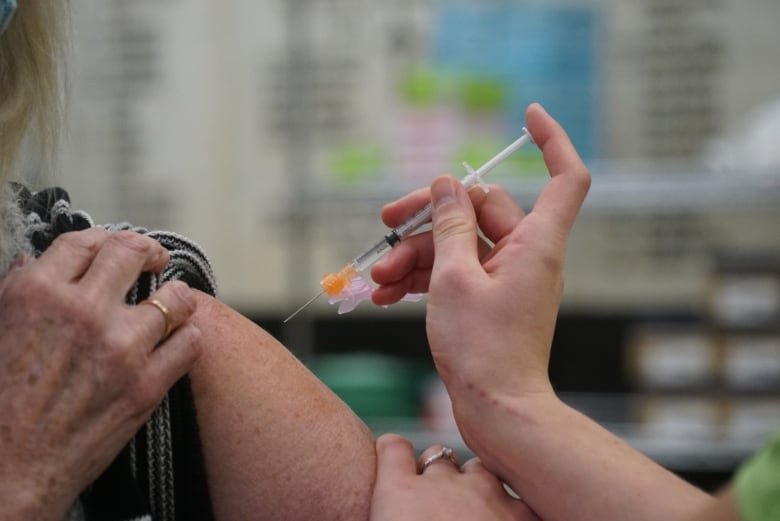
14, 185, 217, 521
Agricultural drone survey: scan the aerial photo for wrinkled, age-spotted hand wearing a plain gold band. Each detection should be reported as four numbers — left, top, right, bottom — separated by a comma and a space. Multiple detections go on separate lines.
0, 228, 200, 520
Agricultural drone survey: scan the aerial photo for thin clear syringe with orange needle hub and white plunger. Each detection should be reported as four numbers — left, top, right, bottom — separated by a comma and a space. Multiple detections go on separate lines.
284, 127, 533, 322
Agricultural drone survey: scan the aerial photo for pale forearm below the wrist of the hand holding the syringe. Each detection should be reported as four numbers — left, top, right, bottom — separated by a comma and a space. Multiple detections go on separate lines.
461, 391, 711, 521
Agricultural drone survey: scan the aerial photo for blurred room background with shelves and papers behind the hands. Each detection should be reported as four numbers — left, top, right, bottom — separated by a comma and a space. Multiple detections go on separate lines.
58, 0, 780, 489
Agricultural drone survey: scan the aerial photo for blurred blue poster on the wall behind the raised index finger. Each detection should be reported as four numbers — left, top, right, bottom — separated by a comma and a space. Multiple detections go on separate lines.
431, 0, 602, 159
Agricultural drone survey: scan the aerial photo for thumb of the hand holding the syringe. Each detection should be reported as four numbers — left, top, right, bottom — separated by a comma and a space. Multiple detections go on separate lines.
431, 176, 479, 269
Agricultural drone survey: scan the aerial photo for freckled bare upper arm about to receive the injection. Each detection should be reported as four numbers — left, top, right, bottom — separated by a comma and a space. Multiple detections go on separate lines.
186, 296, 376, 520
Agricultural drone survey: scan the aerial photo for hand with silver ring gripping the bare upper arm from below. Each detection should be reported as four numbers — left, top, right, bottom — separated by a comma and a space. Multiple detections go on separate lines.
371, 434, 538, 521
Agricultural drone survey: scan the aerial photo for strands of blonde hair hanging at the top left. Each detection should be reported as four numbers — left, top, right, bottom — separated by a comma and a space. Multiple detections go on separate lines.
0, 0, 67, 186
